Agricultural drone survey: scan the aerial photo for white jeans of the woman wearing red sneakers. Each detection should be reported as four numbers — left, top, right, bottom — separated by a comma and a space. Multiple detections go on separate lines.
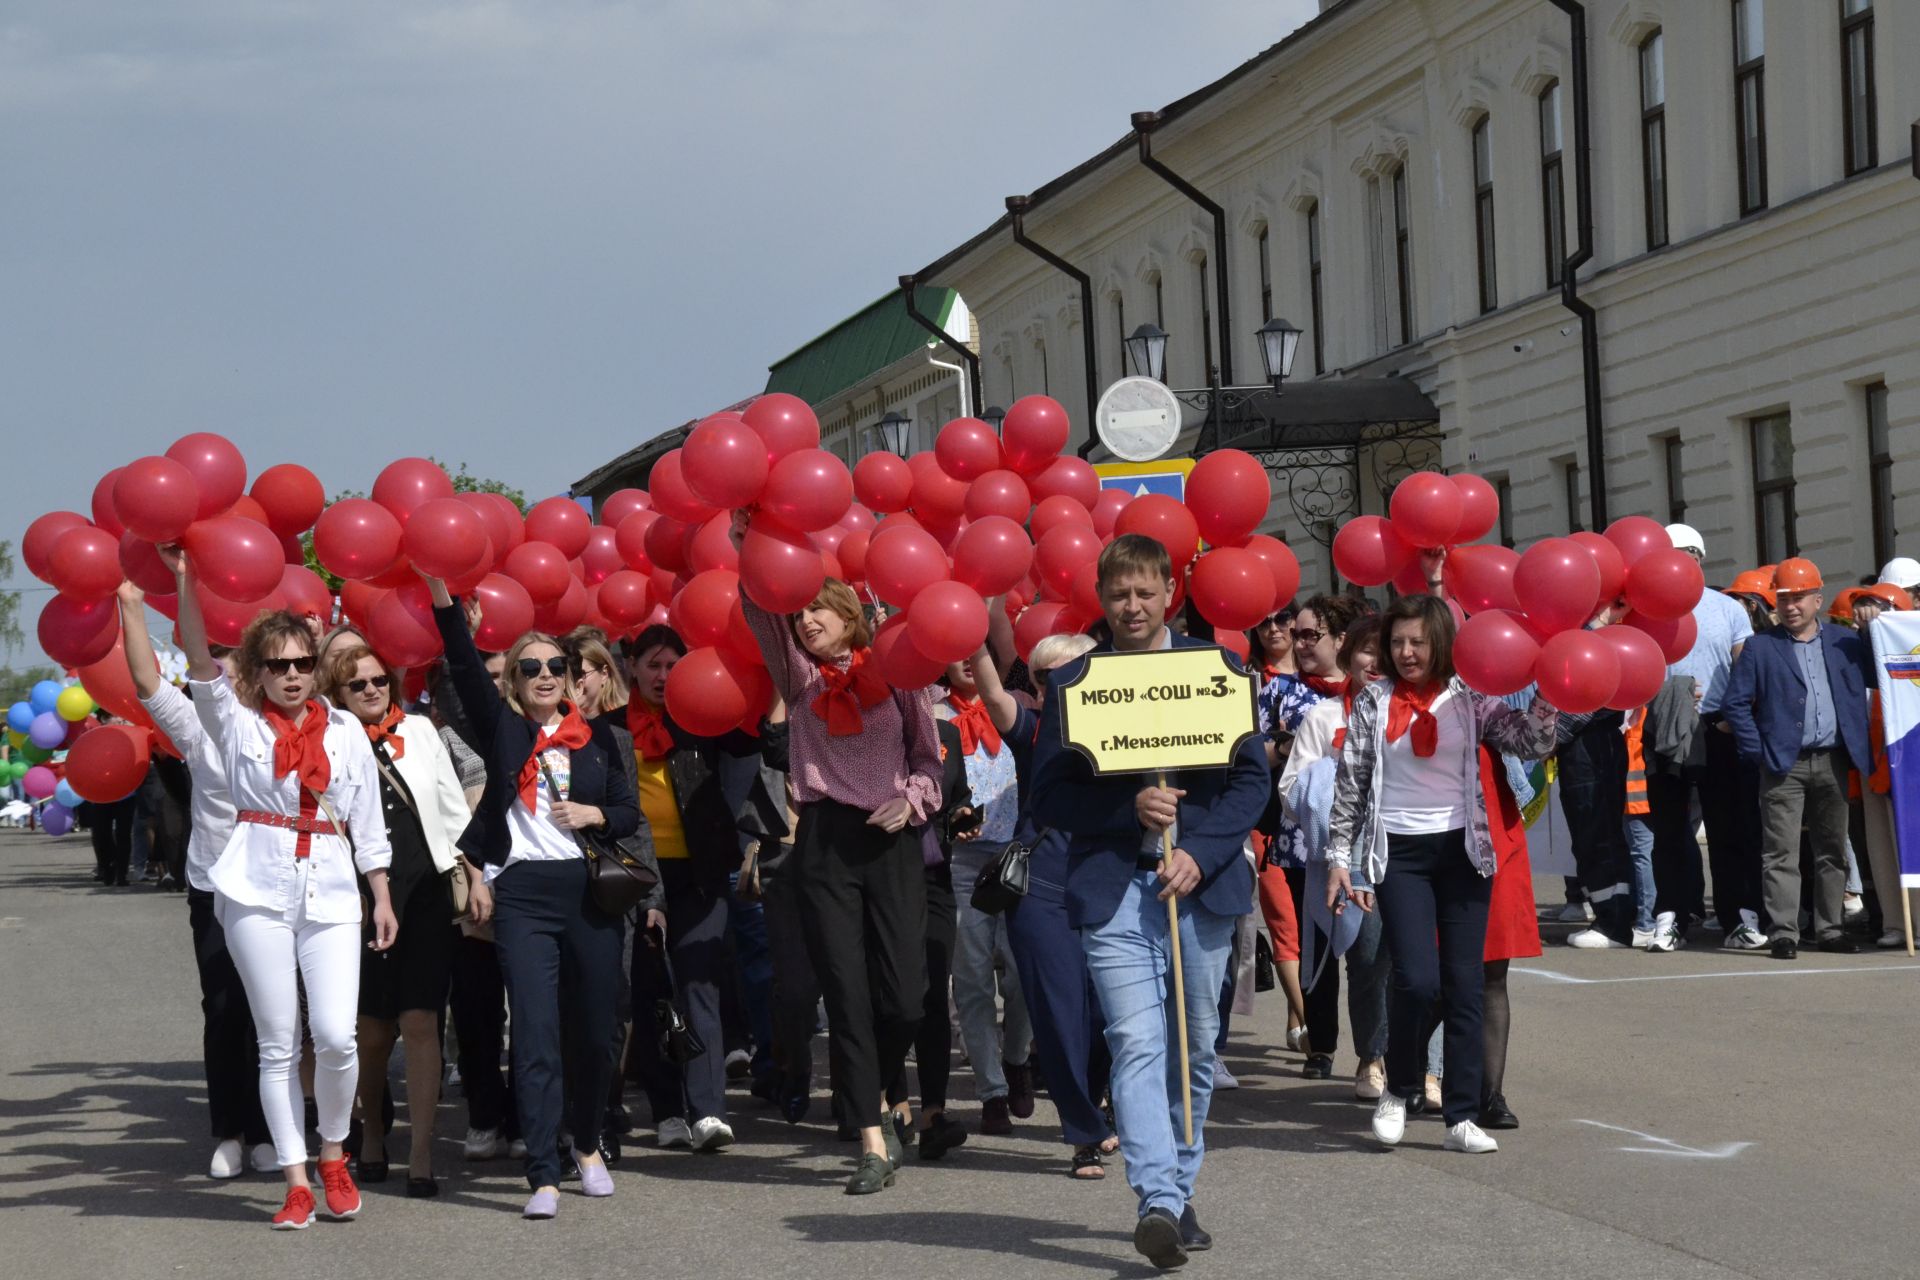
215, 862, 361, 1169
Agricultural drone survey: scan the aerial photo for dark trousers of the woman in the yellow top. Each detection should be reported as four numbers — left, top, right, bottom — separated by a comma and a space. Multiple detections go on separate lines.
628, 858, 733, 1126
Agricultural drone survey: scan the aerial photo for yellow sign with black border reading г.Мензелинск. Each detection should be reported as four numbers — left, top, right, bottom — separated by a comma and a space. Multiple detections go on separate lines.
1060, 645, 1260, 773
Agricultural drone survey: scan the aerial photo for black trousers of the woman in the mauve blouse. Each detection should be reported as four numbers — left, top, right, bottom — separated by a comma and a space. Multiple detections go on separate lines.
791, 800, 927, 1128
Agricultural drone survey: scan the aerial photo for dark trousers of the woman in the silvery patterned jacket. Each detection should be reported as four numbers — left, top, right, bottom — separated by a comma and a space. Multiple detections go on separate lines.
1374, 831, 1494, 1125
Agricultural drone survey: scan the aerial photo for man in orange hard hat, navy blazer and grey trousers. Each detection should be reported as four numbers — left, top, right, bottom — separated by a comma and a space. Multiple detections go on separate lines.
1720, 558, 1874, 960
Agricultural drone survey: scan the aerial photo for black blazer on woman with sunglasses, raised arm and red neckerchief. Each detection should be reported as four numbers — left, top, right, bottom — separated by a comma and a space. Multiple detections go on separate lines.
434, 601, 651, 864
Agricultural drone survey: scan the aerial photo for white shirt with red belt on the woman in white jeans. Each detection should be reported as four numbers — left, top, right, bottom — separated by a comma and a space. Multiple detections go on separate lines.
194, 676, 394, 925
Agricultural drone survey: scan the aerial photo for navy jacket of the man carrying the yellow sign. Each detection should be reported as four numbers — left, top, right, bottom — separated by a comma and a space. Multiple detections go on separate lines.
1031, 635, 1273, 929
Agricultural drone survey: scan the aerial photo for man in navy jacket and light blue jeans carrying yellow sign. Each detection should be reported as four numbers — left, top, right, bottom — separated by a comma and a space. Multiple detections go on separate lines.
1033, 533, 1273, 1268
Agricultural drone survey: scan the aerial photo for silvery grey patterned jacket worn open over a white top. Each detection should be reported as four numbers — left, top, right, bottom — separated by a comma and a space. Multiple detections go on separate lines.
1327, 676, 1559, 885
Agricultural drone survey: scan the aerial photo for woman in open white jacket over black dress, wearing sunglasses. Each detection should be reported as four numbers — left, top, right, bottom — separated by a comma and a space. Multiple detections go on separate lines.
321, 635, 486, 1197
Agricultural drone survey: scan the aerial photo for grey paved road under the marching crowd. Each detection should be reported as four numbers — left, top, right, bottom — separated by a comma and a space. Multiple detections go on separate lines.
0, 831, 1920, 1280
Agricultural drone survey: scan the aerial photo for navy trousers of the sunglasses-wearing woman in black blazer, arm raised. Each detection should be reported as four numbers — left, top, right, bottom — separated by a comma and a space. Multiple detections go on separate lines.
493, 858, 620, 1188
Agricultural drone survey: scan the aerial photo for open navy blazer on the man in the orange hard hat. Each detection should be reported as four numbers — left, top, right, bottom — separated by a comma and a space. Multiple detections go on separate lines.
1720, 622, 1874, 775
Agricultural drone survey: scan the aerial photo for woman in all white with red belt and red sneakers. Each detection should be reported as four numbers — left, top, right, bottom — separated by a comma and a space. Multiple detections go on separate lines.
163, 547, 397, 1230
